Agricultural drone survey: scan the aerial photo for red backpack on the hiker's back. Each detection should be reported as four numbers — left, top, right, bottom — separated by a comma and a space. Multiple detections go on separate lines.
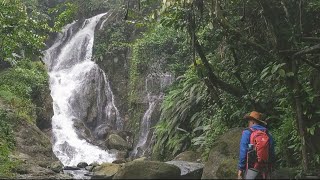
249, 128, 270, 169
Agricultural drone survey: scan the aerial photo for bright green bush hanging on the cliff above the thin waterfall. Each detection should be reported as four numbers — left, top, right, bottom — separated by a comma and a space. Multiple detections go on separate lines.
129, 25, 190, 101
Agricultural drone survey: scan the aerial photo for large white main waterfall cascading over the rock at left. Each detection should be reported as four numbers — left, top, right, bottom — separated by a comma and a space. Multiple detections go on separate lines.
45, 13, 123, 166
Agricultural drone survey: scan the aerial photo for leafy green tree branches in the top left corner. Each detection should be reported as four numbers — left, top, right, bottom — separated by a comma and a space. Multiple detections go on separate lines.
0, 0, 50, 64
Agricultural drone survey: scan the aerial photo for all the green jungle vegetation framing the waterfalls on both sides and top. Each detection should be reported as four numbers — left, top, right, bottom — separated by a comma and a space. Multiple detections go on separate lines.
0, 0, 320, 177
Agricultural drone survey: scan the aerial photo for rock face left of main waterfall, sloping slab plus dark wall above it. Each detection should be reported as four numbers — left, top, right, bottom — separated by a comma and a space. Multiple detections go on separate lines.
2, 82, 71, 179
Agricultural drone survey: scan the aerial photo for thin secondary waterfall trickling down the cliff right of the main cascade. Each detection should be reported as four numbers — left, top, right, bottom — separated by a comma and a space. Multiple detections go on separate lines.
132, 73, 173, 157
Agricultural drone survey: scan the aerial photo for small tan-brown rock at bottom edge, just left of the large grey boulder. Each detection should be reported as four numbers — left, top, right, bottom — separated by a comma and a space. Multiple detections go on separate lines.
92, 163, 121, 179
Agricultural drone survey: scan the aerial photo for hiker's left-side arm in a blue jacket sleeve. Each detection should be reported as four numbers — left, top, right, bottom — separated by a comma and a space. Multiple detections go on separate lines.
238, 130, 251, 173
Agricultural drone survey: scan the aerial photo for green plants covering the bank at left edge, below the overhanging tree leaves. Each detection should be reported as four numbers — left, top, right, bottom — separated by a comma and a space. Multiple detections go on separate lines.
0, 60, 48, 178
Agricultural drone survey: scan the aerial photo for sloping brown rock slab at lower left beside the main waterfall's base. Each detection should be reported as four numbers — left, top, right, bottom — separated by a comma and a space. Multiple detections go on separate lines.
12, 120, 70, 179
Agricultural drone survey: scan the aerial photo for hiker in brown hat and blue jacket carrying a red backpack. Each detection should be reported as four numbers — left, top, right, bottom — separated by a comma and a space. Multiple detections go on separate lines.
238, 111, 275, 179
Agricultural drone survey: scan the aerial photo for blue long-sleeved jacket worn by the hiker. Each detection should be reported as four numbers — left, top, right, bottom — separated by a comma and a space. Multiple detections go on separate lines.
238, 125, 275, 170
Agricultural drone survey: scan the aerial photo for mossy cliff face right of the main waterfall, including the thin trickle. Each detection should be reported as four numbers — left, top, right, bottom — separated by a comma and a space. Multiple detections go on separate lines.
94, 12, 173, 156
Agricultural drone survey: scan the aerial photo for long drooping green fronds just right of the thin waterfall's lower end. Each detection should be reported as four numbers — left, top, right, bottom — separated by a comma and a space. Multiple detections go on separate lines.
153, 70, 212, 159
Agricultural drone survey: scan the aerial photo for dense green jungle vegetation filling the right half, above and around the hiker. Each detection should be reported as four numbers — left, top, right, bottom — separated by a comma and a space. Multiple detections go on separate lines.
120, 0, 320, 172
